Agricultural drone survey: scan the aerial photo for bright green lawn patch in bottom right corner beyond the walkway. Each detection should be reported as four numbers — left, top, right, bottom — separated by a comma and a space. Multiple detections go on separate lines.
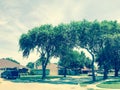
97, 78, 120, 89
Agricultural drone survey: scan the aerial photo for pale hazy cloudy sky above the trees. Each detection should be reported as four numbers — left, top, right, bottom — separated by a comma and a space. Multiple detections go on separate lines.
0, 0, 120, 65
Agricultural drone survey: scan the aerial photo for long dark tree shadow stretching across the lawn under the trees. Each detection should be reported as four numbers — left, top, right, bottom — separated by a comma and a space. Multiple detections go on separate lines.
11, 77, 101, 86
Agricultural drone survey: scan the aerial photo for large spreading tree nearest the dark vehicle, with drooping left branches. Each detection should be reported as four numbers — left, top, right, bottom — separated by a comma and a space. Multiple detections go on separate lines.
19, 24, 74, 79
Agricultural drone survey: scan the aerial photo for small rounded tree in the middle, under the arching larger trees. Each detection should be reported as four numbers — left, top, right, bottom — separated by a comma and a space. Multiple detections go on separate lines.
59, 50, 88, 77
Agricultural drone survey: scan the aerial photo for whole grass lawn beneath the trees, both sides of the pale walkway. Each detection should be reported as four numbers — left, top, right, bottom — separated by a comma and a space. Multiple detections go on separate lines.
11, 75, 120, 90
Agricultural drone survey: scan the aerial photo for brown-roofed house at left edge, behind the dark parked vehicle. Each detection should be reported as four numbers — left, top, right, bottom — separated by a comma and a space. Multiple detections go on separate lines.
0, 58, 26, 76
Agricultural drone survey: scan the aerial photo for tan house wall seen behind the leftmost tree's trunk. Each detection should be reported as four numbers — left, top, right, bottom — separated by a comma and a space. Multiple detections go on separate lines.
37, 63, 58, 75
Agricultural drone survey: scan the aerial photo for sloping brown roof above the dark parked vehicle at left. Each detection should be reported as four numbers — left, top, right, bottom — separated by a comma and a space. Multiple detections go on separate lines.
0, 58, 25, 69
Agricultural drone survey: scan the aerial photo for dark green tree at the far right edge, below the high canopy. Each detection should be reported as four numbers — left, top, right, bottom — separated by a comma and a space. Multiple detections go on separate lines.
105, 35, 120, 77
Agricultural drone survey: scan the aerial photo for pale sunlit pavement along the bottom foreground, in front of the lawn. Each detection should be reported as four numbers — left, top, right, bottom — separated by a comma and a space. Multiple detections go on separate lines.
0, 78, 86, 90
